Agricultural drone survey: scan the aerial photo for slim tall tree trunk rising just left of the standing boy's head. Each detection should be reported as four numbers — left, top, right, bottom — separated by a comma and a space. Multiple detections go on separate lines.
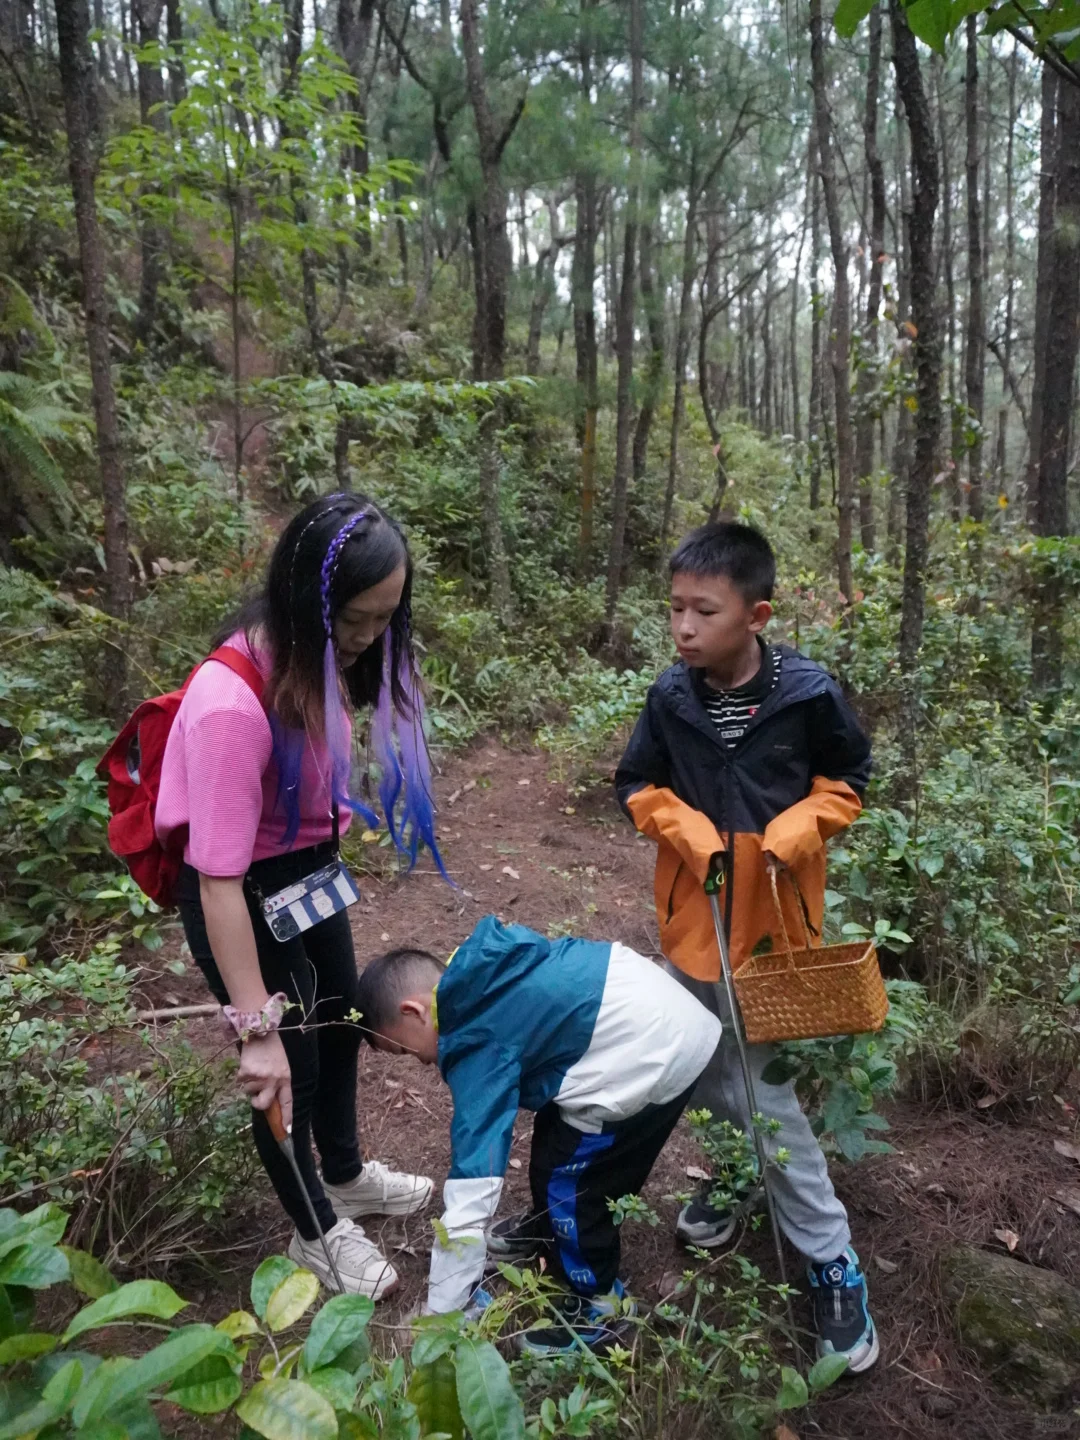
603, 0, 644, 624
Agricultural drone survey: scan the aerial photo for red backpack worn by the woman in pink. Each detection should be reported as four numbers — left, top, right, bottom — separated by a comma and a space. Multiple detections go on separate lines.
98, 645, 262, 906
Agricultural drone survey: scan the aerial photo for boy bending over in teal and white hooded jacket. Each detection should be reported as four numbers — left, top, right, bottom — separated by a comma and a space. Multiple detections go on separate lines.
359, 916, 720, 1354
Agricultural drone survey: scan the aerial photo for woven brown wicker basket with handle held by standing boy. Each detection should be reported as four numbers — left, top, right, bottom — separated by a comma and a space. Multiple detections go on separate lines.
734, 870, 888, 1044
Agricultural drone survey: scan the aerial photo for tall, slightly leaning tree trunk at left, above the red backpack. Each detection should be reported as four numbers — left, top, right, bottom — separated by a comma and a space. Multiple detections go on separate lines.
56, 0, 131, 714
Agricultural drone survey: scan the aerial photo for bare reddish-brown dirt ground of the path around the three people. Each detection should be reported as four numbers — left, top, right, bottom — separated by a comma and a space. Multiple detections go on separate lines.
137, 740, 1080, 1440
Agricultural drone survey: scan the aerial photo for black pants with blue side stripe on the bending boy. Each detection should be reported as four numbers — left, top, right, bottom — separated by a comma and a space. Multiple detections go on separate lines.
528, 1086, 693, 1295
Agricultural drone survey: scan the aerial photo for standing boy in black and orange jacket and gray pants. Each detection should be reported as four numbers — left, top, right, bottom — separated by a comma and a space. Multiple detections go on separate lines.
615, 523, 878, 1372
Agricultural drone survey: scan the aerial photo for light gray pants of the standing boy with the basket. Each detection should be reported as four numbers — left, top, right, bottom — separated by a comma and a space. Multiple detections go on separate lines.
665, 962, 851, 1260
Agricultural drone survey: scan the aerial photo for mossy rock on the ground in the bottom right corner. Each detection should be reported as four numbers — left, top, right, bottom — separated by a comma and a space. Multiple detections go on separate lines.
942, 1246, 1080, 1408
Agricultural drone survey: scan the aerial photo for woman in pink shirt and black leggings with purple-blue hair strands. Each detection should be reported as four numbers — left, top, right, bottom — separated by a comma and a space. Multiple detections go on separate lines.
156, 494, 442, 1299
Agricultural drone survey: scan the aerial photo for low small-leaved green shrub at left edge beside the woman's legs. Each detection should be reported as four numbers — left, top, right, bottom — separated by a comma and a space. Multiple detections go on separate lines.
0, 940, 256, 1263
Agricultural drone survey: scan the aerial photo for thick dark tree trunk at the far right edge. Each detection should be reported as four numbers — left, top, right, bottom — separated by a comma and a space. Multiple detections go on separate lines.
1031, 82, 1080, 691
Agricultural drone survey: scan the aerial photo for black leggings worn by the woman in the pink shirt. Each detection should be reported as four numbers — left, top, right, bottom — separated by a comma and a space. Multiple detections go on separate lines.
177, 844, 364, 1240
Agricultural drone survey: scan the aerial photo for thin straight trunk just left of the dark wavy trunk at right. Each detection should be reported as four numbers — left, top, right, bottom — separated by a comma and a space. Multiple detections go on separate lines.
855, 4, 886, 553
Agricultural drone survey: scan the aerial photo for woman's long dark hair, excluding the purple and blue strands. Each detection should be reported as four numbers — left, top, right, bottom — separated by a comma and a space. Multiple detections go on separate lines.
223, 492, 413, 737
